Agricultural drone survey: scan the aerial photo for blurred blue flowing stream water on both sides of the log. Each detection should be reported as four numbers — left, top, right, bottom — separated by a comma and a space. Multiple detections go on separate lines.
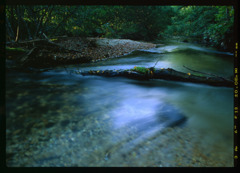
6, 40, 233, 167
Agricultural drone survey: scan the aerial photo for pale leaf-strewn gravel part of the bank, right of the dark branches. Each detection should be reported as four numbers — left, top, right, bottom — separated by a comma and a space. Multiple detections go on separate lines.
54, 37, 156, 62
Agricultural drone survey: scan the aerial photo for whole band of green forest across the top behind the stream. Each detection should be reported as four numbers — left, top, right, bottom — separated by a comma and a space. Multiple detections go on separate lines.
6, 5, 234, 51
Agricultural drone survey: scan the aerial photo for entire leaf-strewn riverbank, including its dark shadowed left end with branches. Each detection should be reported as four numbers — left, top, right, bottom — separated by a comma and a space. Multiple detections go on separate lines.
7, 37, 156, 67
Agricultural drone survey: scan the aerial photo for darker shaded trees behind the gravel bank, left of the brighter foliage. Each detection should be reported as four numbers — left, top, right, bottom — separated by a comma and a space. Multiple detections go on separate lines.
6, 5, 173, 40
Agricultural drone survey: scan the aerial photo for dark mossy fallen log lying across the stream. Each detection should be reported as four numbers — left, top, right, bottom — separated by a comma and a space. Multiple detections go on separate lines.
79, 67, 234, 87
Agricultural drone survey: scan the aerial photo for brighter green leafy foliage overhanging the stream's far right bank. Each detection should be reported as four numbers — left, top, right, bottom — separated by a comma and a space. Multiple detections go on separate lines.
165, 6, 234, 49
